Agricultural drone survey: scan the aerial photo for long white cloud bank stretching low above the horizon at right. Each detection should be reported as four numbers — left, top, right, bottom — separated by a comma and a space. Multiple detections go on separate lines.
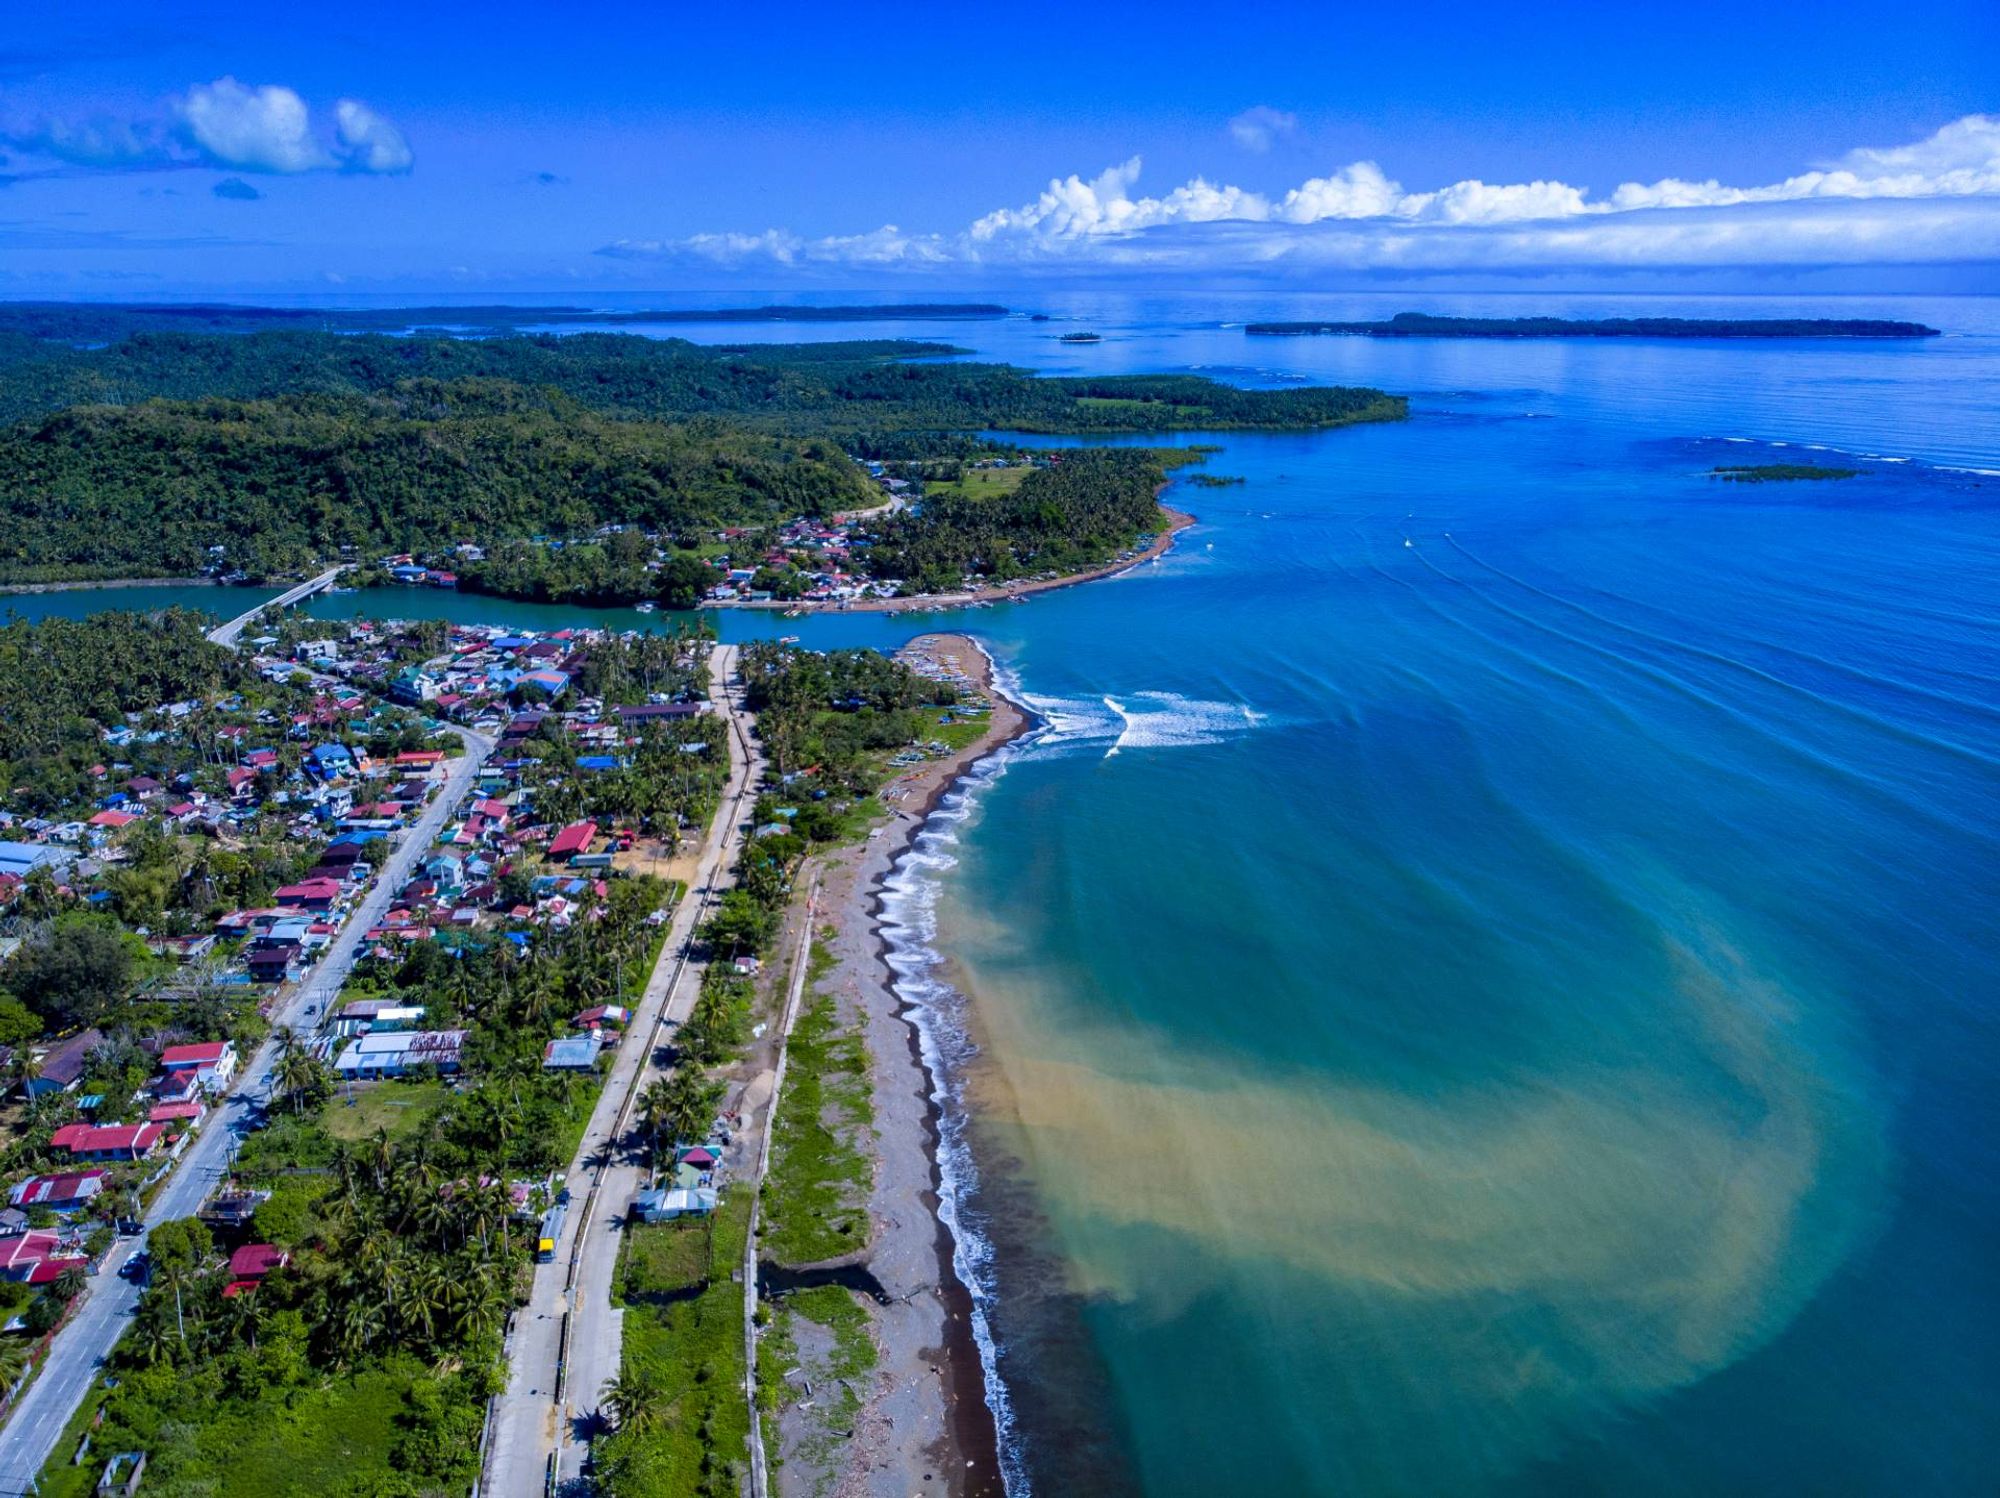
602, 106, 2000, 270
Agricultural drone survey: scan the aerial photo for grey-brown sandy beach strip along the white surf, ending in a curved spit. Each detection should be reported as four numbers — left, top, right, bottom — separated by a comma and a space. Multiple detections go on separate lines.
804, 634, 1036, 1498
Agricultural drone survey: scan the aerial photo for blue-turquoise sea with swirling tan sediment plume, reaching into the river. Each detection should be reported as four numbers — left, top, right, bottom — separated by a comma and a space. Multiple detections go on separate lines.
14, 294, 2000, 1498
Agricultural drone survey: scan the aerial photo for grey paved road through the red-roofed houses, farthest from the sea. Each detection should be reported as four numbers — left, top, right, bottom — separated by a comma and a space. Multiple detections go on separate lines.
0, 728, 494, 1498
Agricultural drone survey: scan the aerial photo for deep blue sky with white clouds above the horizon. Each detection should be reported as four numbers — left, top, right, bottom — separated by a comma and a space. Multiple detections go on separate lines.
0, 0, 2000, 296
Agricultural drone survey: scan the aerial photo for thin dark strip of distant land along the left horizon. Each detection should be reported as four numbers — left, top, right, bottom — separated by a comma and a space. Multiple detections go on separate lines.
0, 302, 1008, 342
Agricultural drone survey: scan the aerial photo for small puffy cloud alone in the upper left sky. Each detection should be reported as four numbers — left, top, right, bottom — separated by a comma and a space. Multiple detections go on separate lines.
0, 78, 414, 174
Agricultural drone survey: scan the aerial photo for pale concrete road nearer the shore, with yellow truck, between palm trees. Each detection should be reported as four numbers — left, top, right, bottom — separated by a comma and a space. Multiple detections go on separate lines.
482, 646, 764, 1498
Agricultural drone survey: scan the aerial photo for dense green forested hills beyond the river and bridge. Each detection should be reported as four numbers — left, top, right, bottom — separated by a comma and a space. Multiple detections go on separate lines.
0, 320, 1406, 584
